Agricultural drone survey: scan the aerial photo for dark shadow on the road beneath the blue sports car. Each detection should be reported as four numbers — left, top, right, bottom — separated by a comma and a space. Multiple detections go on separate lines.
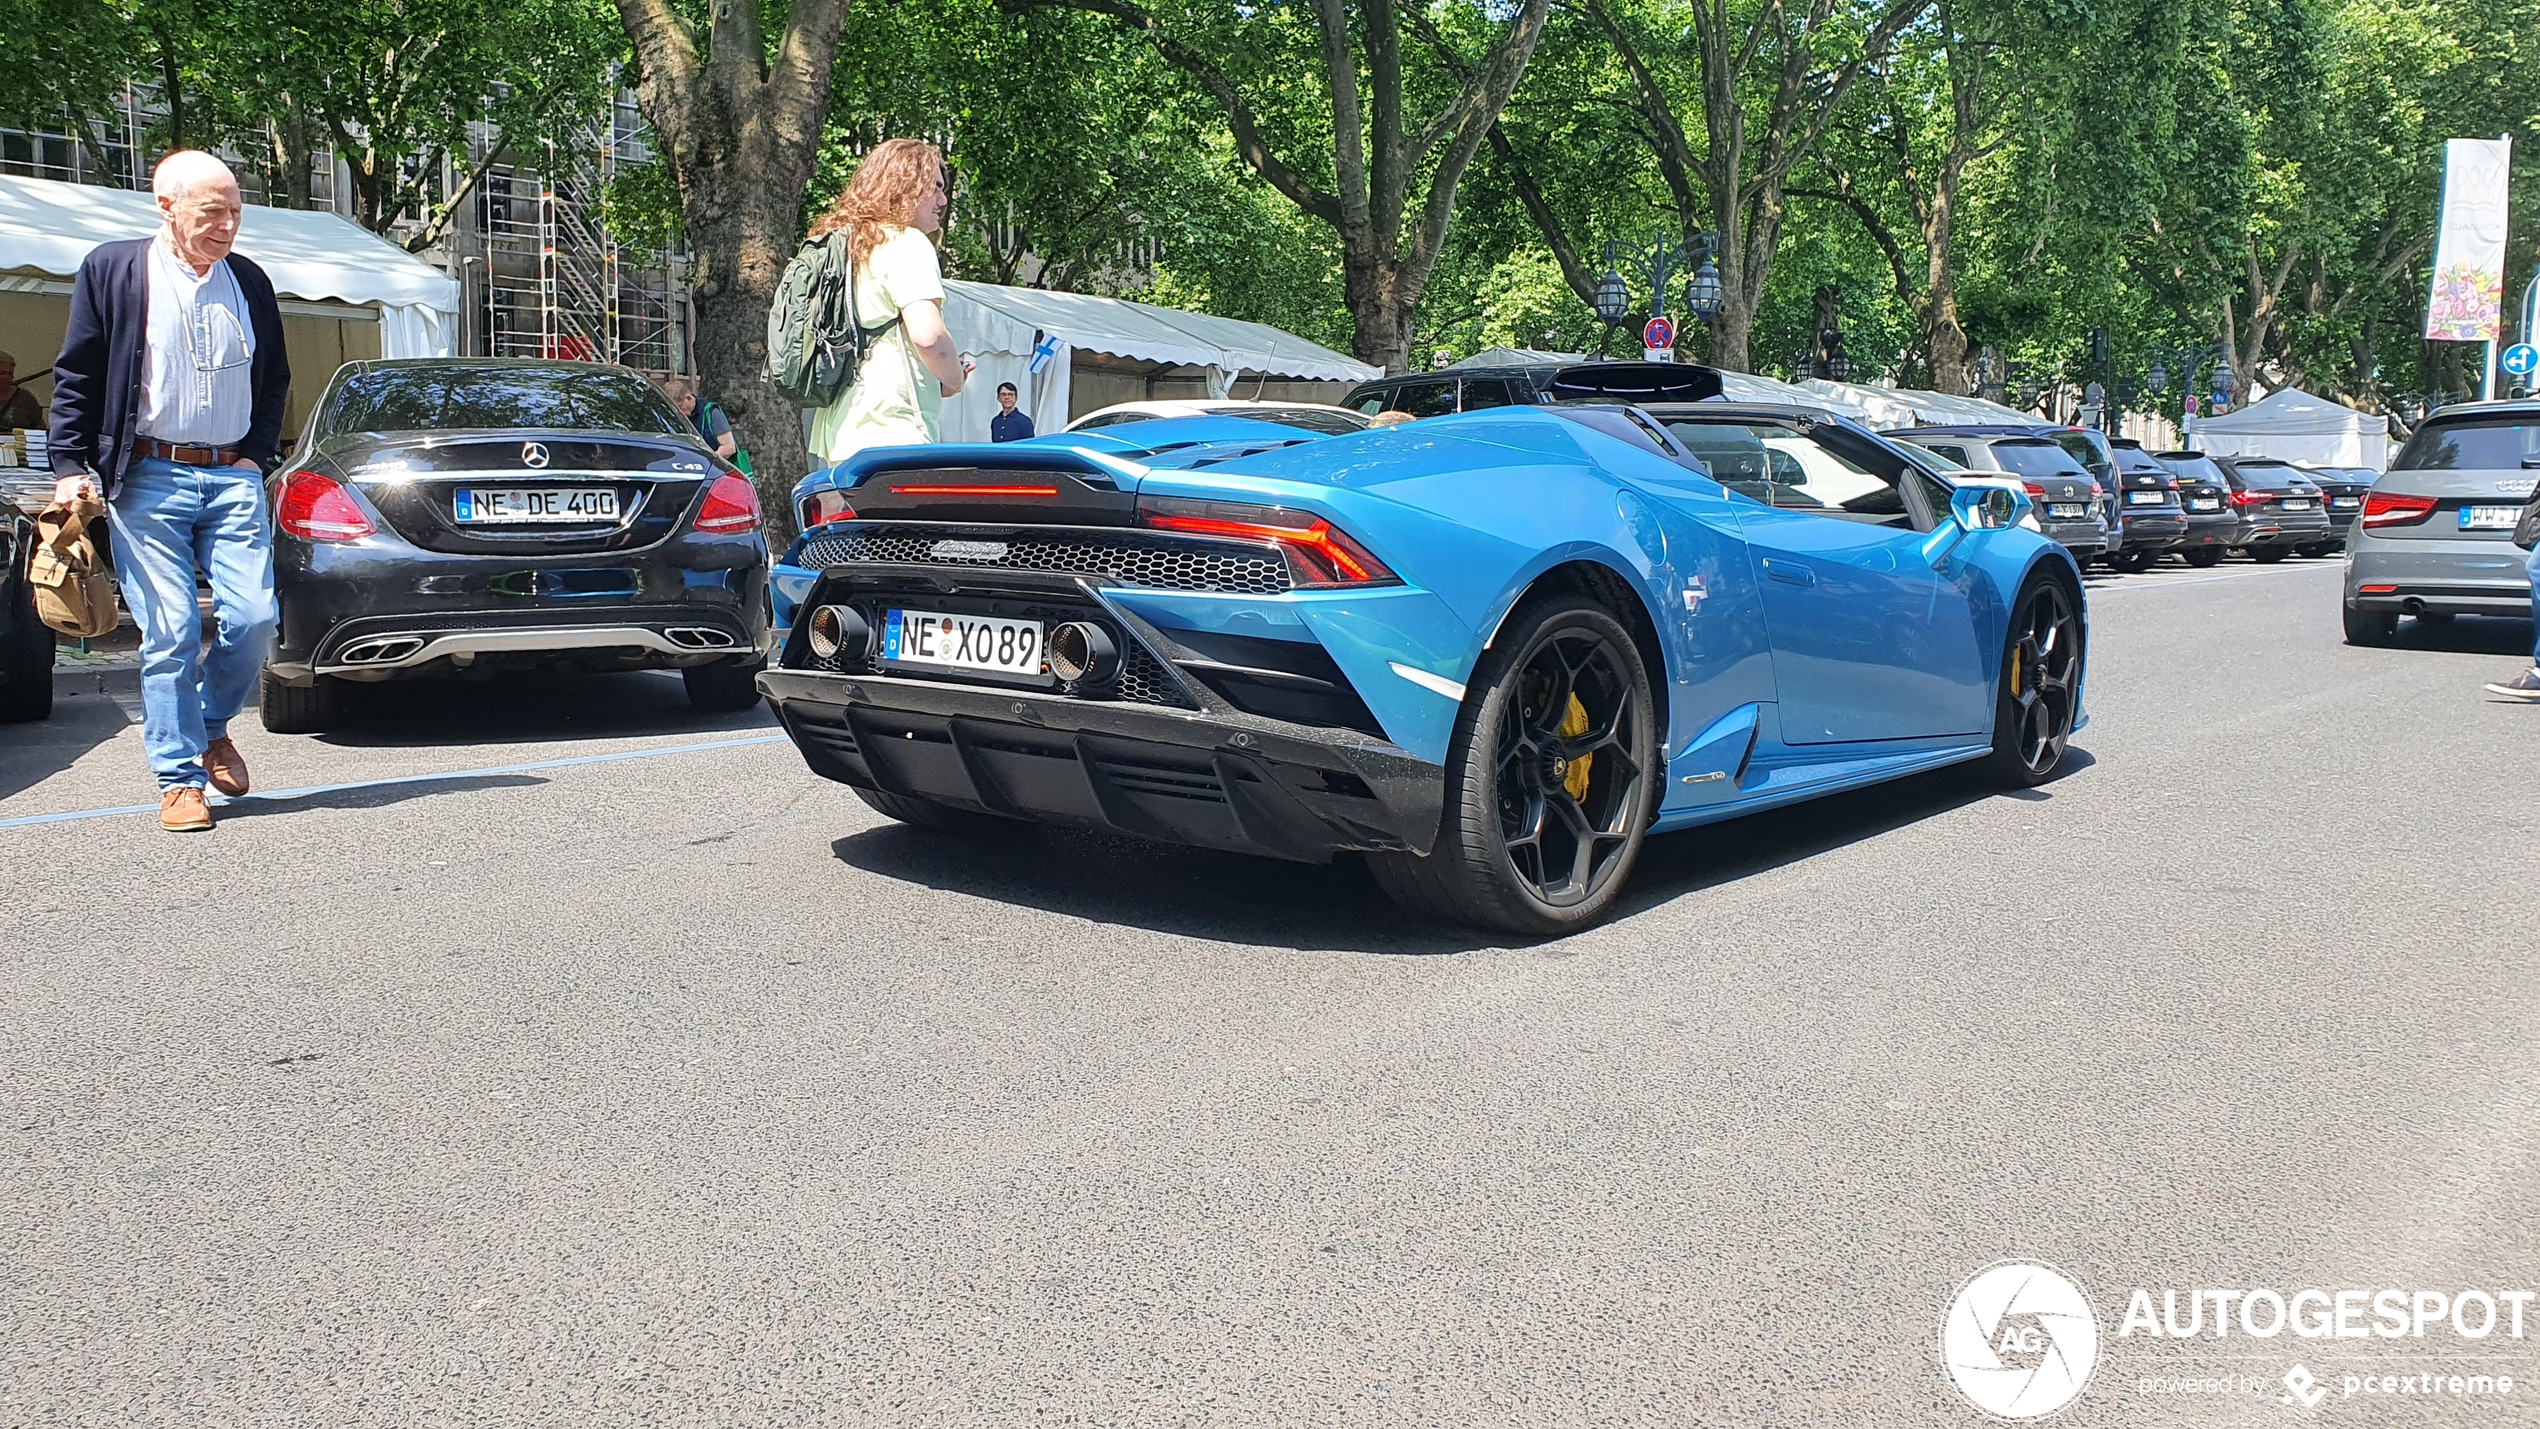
831, 749, 2093, 954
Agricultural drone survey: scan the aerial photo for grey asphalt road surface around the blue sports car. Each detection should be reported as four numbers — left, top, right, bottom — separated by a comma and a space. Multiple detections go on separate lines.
0, 561, 2540, 1426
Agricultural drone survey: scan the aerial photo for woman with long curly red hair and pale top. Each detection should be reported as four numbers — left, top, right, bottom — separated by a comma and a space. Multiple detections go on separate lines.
810, 140, 970, 464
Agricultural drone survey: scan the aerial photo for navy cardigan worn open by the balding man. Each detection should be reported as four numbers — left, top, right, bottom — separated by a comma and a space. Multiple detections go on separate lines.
48, 239, 292, 500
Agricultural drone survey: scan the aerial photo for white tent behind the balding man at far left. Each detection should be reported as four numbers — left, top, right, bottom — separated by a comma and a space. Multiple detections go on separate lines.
0, 175, 460, 431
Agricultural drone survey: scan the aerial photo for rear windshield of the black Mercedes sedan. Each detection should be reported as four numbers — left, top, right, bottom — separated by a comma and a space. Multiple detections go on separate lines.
318, 363, 696, 439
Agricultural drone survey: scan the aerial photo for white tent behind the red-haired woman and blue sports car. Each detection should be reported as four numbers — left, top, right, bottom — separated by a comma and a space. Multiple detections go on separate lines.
942, 279, 1384, 442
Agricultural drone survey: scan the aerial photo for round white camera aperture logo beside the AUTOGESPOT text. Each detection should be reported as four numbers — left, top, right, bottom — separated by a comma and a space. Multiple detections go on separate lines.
1941, 1261, 2098, 1419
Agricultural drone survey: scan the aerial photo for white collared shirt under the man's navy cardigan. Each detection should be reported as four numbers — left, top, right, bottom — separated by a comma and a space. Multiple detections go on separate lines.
140, 228, 257, 447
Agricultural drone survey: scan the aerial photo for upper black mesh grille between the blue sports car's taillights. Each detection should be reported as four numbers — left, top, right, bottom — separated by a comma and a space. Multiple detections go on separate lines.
803, 528, 1290, 594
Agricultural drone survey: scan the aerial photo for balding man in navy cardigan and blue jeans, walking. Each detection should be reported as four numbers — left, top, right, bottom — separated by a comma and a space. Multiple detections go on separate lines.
51, 150, 292, 833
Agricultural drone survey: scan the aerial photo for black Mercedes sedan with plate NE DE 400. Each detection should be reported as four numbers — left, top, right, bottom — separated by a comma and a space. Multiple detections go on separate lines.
262, 358, 767, 734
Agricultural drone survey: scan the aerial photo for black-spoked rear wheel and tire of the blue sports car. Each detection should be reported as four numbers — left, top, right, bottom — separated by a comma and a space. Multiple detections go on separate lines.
1367, 594, 1666, 937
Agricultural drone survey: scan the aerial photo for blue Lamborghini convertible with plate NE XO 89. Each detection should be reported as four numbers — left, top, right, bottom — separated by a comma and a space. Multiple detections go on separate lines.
759, 401, 2088, 934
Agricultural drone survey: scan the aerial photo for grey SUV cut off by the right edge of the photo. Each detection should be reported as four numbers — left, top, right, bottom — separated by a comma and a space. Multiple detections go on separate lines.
2344, 401, 2540, 645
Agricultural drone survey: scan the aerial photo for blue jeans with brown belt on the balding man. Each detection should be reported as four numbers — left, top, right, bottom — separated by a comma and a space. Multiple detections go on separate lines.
109, 457, 277, 792
